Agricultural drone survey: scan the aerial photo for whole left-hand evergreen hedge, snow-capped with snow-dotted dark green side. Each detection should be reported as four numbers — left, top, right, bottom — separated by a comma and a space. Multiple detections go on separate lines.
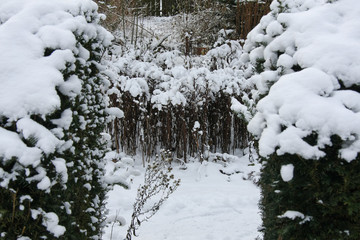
0, 0, 112, 239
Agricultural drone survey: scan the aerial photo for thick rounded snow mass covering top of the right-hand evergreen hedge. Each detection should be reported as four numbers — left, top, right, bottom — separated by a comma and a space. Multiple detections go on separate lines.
243, 0, 360, 161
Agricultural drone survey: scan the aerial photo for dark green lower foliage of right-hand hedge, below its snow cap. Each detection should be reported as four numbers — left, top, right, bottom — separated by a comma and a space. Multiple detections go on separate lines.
260, 136, 360, 240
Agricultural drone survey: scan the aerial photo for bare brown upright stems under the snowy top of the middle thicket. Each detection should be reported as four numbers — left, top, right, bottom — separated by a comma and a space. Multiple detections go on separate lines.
110, 87, 248, 162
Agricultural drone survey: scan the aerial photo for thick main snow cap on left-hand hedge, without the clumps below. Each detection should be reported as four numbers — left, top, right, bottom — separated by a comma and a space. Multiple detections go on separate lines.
0, 0, 110, 119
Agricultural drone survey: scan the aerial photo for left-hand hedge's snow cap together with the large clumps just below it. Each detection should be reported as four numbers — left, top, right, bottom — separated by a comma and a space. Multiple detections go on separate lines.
0, 0, 111, 169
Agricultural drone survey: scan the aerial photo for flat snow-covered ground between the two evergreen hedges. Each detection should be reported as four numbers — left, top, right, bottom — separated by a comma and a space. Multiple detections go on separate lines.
103, 155, 261, 240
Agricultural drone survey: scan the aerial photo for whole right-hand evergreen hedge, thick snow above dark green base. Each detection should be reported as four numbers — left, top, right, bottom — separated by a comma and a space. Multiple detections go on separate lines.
243, 0, 360, 240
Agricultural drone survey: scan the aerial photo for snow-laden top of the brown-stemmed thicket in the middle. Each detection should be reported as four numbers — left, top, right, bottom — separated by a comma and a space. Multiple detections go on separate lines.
105, 41, 245, 110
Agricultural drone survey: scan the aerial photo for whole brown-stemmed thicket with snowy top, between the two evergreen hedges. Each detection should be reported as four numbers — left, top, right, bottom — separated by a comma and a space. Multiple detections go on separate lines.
106, 41, 247, 159
